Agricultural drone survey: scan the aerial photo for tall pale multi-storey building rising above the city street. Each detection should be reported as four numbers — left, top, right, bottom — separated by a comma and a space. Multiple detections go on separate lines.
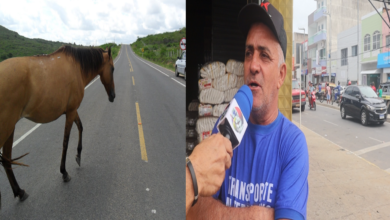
308, 0, 382, 83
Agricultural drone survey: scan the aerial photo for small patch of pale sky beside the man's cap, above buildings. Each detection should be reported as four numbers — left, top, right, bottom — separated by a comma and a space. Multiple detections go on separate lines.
293, 0, 317, 34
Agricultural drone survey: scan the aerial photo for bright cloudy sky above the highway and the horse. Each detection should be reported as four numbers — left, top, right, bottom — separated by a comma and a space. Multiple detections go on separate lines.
0, 0, 186, 45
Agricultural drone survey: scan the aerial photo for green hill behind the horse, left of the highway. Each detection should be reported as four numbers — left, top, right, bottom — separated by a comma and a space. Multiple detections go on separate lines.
0, 25, 120, 62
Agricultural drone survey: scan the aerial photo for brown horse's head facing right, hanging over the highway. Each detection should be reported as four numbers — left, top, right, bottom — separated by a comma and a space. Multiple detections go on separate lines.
99, 47, 115, 102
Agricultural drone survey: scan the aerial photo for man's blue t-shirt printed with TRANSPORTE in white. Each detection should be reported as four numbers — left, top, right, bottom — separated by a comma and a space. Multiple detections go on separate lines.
213, 112, 309, 220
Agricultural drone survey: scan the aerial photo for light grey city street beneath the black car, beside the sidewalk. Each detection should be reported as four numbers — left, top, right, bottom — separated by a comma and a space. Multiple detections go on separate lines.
293, 105, 390, 172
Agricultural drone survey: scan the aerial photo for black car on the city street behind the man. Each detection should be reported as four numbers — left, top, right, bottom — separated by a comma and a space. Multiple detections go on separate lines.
340, 86, 387, 126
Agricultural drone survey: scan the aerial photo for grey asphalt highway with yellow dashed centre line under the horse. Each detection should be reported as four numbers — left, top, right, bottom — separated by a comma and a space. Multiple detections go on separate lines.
0, 45, 185, 219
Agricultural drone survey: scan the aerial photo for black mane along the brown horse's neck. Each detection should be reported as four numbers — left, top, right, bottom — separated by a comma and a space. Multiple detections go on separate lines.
50, 46, 111, 75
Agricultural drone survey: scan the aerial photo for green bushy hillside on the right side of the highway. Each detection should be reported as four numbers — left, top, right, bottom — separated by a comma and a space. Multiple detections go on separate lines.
130, 27, 186, 71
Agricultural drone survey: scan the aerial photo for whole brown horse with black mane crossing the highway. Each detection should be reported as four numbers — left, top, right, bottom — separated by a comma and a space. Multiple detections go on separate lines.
0, 46, 115, 207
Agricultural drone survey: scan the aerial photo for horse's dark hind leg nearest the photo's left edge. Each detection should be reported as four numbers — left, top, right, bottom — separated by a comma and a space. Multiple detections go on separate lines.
2, 131, 28, 201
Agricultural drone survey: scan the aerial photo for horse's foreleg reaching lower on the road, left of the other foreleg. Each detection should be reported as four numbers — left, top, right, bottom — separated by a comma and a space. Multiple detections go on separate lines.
60, 111, 77, 182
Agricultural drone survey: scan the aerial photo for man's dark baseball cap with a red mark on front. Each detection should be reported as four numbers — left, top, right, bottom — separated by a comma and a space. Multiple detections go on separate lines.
238, 0, 287, 59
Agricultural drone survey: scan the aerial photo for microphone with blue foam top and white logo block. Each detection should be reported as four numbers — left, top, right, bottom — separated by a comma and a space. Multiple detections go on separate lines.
217, 85, 253, 149
